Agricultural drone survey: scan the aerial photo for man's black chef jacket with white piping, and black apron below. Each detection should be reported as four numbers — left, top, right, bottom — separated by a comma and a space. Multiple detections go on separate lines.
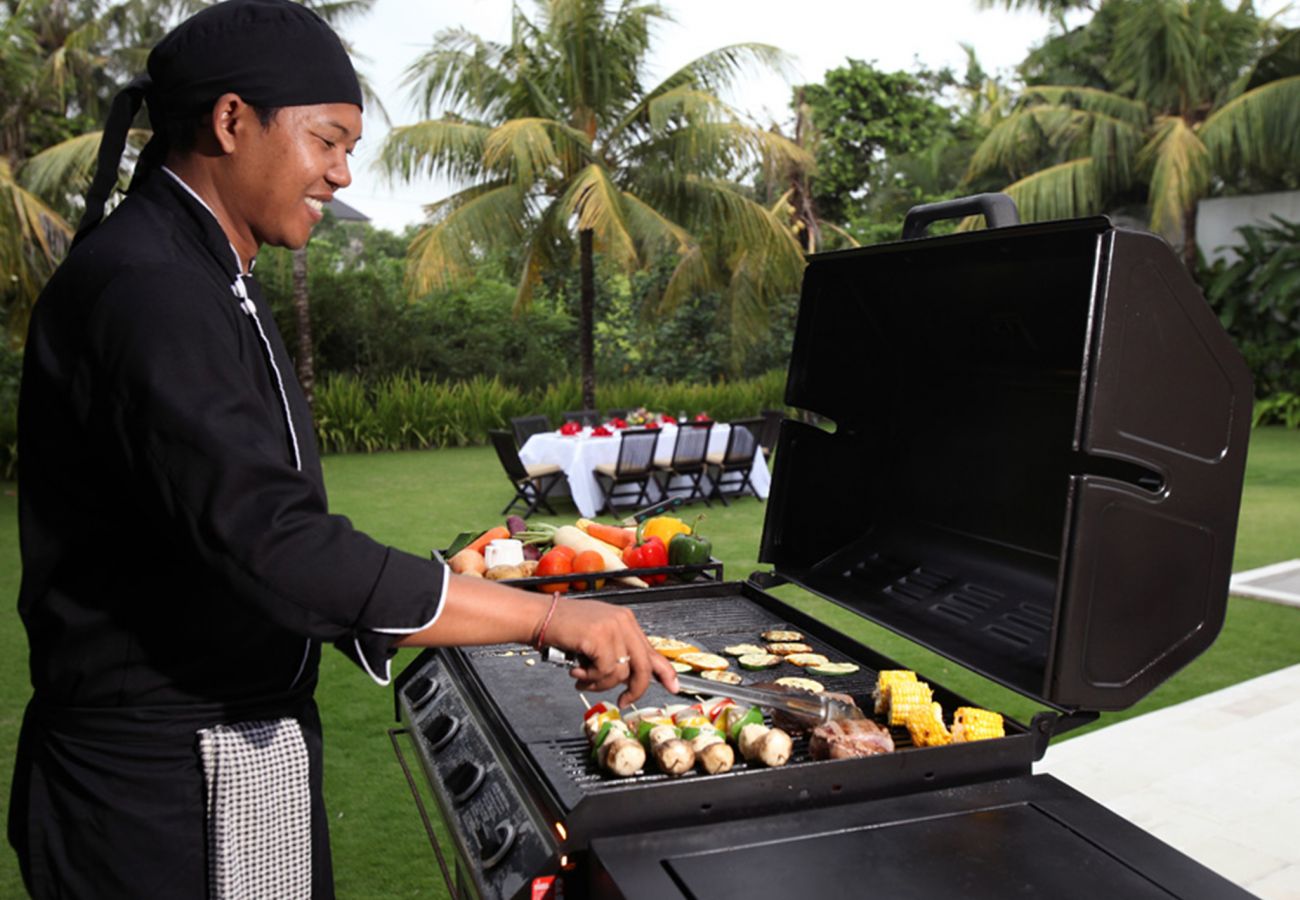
10, 170, 446, 896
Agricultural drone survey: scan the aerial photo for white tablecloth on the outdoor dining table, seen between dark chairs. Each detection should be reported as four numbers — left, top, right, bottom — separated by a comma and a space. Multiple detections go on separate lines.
519, 423, 772, 518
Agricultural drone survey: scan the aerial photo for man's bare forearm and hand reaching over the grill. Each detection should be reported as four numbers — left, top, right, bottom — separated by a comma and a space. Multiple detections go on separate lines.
395, 575, 677, 706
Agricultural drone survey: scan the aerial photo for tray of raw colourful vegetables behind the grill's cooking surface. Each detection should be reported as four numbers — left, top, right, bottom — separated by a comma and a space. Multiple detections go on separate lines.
433, 514, 723, 594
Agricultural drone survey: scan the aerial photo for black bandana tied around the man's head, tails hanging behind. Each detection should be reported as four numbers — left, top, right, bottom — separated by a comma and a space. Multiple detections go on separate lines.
77, 0, 361, 238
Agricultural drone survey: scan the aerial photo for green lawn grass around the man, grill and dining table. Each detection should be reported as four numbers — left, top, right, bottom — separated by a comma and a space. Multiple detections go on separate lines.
0, 428, 1300, 899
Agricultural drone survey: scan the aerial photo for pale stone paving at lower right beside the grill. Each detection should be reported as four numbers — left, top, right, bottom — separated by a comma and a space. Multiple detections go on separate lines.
1034, 666, 1300, 900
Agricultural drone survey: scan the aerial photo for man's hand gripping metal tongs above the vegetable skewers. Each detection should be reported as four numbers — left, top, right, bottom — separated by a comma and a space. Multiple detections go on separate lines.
546, 598, 677, 706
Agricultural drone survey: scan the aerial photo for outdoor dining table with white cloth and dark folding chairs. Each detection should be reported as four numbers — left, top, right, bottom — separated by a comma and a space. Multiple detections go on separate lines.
490, 410, 783, 519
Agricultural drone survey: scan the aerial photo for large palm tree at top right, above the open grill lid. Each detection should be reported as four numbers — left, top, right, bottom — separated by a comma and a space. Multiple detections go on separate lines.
966, 0, 1300, 268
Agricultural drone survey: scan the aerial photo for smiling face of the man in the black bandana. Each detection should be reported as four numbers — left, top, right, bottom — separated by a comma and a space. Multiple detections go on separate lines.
205, 95, 361, 259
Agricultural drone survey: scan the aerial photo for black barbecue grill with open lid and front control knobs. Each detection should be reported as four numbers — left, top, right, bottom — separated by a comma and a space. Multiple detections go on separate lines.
393, 195, 1251, 900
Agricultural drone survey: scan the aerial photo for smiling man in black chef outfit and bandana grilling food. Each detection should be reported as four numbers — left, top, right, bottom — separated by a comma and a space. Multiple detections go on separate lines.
9, 0, 676, 897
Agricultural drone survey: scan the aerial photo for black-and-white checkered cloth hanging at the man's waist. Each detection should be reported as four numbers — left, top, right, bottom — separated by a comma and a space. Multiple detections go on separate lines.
199, 718, 312, 900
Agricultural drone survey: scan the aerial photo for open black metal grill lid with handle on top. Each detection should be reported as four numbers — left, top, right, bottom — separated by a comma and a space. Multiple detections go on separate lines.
759, 195, 1252, 709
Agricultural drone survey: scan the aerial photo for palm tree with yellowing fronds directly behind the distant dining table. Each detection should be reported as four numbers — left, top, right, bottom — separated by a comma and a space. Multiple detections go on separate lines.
381, 0, 807, 407
